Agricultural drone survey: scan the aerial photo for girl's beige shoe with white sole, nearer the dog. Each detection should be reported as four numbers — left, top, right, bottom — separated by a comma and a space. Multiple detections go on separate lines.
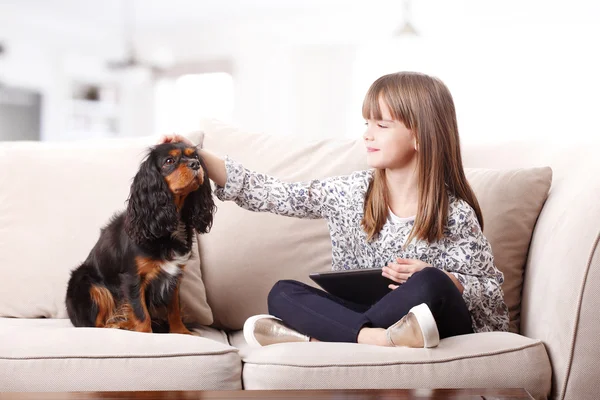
244, 314, 310, 347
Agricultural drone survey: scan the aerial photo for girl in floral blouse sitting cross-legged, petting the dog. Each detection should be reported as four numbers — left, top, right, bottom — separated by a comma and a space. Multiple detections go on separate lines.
163, 73, 508, 347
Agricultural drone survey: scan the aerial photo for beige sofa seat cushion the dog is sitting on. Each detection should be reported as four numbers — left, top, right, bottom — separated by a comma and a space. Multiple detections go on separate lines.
0, 318, 242, 392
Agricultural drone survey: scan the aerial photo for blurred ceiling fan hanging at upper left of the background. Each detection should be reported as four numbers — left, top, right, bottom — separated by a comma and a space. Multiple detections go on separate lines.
107, 0, 165, 77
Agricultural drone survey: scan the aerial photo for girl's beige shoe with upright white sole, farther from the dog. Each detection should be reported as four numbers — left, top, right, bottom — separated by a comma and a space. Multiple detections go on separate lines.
385, 303, 440, 348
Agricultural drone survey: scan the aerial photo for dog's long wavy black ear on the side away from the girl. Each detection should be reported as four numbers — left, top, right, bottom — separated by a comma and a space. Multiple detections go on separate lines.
125, 153, 177, 244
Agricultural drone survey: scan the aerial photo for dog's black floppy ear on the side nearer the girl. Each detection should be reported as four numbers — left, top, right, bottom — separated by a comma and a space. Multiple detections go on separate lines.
182, 158, 217, 234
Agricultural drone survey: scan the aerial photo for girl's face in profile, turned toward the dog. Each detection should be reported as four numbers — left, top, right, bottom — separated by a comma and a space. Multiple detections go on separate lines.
363, 99, 417, 169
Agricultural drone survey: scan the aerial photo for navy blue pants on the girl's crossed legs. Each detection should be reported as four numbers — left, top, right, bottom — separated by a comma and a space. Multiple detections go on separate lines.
267, 267, 473, 343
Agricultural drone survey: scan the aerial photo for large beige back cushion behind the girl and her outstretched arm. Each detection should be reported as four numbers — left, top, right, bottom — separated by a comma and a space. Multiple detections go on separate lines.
199, 120, 551, 331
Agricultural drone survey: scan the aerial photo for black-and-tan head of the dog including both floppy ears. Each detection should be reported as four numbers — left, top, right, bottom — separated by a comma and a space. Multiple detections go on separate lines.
125, 143, 215, 244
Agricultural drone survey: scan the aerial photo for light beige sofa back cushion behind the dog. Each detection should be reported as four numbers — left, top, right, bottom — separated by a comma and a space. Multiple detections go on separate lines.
0, 133, 212, 324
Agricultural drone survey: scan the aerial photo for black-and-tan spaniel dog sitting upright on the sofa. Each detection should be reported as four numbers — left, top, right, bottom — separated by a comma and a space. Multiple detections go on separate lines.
66, 143, 216, 334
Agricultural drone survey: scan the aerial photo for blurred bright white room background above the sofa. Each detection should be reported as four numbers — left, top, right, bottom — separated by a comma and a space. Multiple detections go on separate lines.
0, 0, 600, 142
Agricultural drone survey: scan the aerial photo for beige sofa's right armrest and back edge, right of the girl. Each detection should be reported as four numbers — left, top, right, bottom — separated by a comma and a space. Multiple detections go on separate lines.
464, 142, 600, 399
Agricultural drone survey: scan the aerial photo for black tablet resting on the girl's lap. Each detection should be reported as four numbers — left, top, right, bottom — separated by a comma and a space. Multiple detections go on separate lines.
309, 268, 397, 305
